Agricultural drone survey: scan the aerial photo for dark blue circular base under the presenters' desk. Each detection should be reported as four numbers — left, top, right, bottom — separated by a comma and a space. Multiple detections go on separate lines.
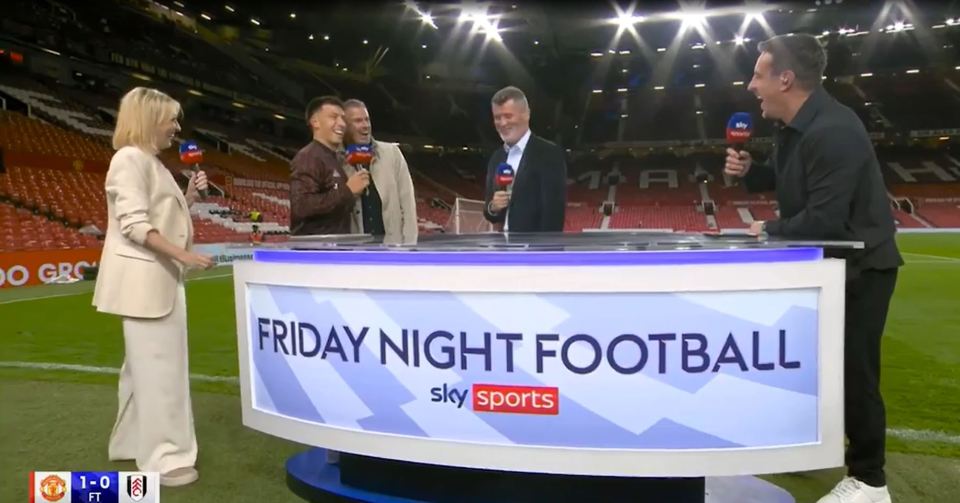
286, 449, 795, 503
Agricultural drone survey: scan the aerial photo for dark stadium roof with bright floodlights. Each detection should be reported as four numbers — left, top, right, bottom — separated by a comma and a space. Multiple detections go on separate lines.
167, 0, 960, 95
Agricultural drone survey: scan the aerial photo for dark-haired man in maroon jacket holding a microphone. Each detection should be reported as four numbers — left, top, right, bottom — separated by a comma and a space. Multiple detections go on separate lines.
290, 96, 370, 235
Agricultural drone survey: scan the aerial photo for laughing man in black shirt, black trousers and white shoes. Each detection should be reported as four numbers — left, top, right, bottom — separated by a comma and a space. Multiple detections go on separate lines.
725, 35, 903, 503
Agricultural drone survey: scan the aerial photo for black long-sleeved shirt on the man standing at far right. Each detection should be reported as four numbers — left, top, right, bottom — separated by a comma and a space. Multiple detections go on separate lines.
744, 86, 903, 269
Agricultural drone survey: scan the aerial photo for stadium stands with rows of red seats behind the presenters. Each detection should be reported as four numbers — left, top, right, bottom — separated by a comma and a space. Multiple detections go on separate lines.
0, 0, 960, 260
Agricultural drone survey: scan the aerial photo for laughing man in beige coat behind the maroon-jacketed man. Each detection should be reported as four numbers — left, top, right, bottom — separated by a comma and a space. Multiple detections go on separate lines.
343, 100, 417, 244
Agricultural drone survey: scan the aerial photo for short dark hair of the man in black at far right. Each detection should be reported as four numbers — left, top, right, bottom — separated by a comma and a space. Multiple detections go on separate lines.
757, 34, 827, 90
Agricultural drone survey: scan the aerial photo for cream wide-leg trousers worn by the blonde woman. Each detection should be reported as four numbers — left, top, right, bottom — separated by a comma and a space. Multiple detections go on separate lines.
108, 283, 197, 473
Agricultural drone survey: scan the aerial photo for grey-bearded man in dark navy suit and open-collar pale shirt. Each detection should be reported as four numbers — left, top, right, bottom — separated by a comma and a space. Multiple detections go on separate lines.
483, 86, 567, 232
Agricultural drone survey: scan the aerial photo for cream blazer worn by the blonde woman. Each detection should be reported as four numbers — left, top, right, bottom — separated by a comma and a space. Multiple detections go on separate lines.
93, 147, 193, 318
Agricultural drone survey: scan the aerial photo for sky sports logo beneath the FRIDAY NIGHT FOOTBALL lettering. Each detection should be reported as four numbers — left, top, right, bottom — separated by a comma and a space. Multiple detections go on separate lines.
430, 384, 560, 416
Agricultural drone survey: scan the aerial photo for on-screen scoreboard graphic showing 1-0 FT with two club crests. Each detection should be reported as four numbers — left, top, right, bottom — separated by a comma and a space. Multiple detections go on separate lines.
30, 472, 160, 503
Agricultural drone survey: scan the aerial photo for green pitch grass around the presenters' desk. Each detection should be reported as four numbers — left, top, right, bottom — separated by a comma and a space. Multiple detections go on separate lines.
0, 234, 960, 503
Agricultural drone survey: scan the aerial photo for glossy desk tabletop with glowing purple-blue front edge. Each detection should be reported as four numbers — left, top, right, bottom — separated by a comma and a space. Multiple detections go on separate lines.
244, 232, 863, 266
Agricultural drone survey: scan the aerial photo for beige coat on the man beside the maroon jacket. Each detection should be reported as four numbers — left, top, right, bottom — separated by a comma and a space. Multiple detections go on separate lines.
343, 140, 418, 244
